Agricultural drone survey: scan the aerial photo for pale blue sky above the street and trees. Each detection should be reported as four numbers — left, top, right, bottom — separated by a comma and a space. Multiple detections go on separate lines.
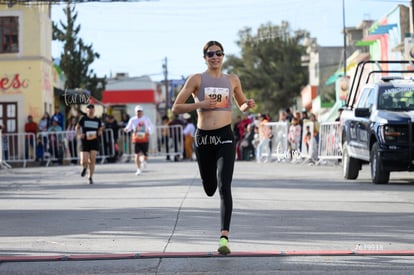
52, 0, 410, 81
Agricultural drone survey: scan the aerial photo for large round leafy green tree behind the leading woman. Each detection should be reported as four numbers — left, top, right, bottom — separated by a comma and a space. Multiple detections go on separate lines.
223, 22, 308, 118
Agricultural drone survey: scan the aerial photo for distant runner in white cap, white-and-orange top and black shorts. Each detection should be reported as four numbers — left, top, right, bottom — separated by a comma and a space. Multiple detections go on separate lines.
124, 105, 153, 176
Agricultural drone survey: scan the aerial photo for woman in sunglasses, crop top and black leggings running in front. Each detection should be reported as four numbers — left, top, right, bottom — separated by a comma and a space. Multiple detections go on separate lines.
172, 41, 256, 255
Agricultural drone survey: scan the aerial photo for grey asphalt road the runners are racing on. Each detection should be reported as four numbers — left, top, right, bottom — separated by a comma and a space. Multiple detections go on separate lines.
0, 158, 414, 274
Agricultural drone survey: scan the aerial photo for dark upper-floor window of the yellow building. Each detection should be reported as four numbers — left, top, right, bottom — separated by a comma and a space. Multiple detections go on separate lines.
0, 16, 19, 53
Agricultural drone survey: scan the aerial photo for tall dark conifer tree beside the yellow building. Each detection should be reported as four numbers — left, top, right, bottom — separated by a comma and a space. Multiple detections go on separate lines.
53, 1, 106, 99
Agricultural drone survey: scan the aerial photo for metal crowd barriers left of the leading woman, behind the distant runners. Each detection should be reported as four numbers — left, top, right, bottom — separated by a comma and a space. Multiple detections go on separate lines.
0, 125, 184, 167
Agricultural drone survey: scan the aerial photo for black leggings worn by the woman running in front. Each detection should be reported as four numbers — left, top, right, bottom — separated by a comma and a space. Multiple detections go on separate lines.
194, 125, 236, 231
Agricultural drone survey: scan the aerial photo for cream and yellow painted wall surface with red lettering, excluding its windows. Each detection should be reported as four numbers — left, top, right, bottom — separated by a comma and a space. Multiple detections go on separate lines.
0, 3, 54, 132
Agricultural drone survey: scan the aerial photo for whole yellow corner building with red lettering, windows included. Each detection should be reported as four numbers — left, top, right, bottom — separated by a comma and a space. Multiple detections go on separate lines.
0, 3, 57, 133
